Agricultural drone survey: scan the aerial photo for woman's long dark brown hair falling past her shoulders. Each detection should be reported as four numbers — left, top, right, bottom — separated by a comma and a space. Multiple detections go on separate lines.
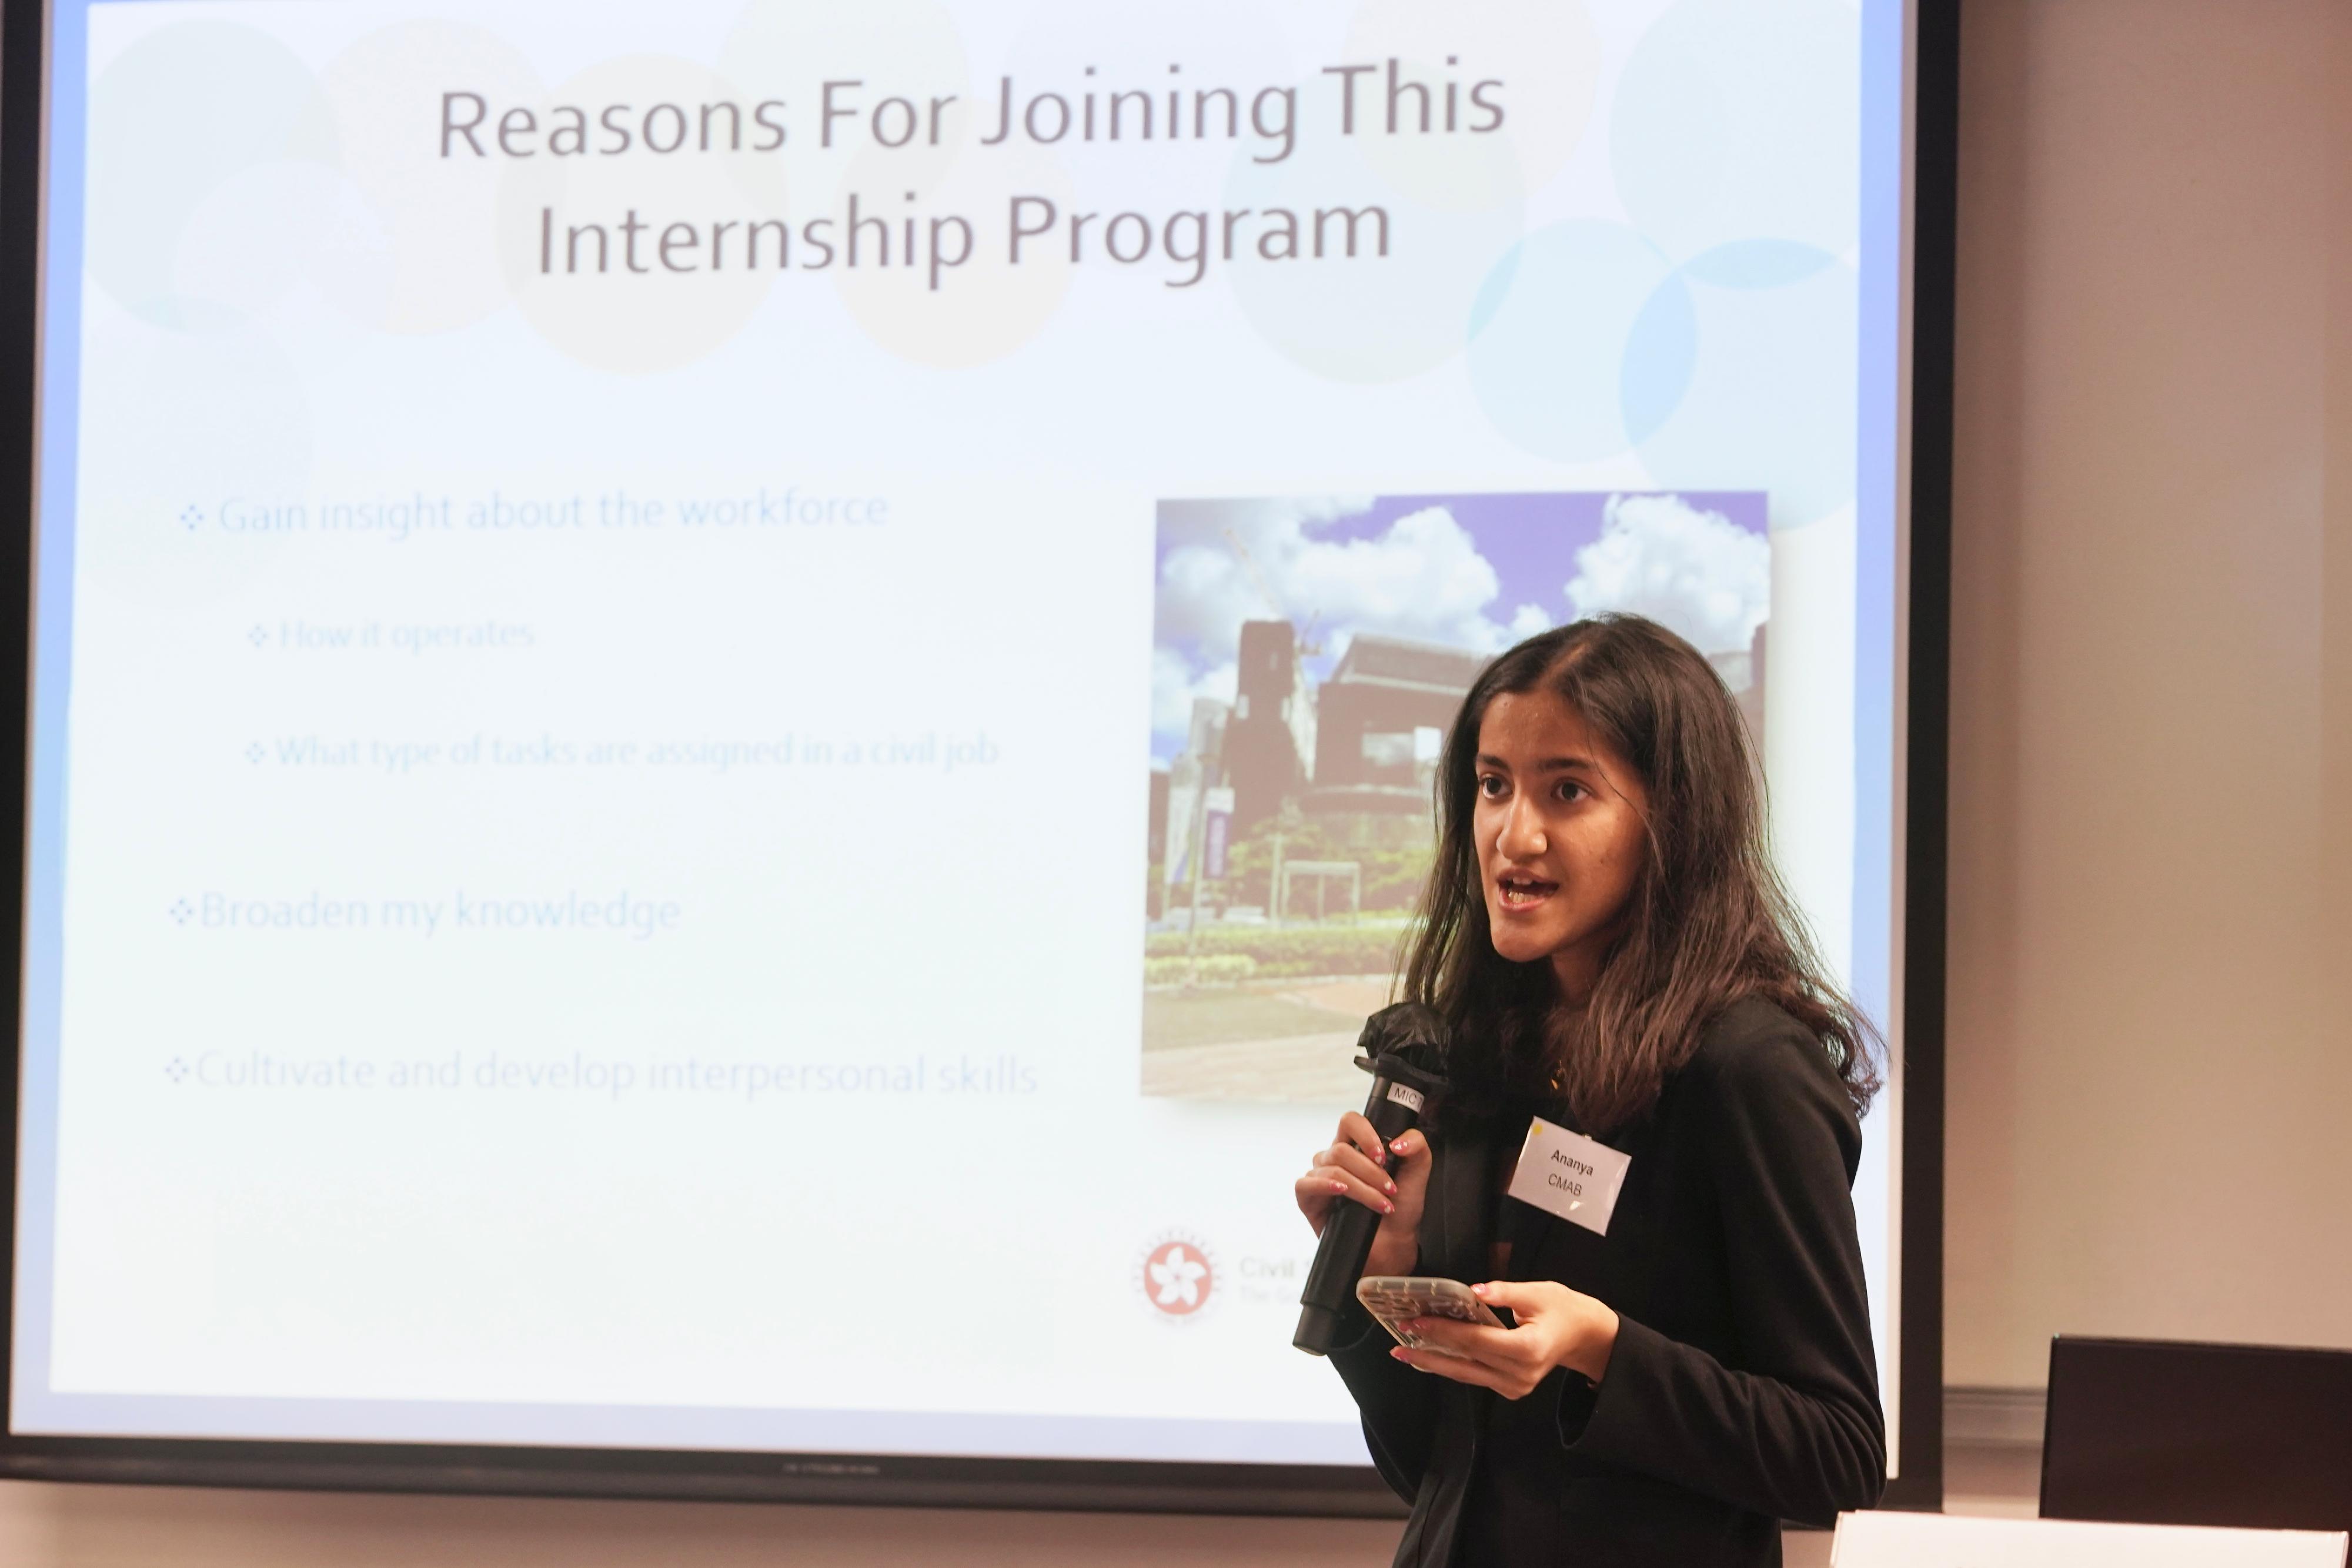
1404, 616, 1882, 1133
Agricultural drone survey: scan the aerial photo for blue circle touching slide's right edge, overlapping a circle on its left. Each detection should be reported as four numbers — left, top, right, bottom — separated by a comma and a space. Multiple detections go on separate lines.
1625, 240, 1856, 527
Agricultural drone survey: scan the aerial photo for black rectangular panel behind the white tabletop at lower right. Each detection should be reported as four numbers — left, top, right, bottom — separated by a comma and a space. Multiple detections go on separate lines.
2042, 1335, 2352, 1530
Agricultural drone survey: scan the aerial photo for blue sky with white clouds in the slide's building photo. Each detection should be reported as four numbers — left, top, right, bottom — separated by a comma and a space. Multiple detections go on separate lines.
1152, 492, 1771, 762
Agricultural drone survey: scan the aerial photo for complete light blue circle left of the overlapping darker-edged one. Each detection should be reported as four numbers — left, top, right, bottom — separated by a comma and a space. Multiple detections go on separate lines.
1470, 219, 1691, 463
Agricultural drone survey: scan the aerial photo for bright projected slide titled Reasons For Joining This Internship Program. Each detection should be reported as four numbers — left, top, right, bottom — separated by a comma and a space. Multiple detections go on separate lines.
9, 0, 1905, 1465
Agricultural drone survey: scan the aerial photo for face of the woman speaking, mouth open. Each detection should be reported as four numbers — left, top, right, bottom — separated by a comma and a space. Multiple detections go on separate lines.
1472, 691, 1649, 1001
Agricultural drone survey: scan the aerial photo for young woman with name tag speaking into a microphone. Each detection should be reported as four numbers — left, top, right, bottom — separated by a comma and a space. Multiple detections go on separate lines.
1296, 616, 1886, 1568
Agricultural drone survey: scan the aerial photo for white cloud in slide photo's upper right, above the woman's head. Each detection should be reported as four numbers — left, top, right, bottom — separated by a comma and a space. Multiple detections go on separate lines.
1566, 496, 1771, 654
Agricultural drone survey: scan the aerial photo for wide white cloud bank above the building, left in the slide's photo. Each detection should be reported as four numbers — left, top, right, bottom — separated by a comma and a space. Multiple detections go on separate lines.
1160, 499, 1503, 661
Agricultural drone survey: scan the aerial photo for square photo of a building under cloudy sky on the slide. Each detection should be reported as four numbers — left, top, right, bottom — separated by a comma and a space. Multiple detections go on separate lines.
1143, 492, 1771, 1105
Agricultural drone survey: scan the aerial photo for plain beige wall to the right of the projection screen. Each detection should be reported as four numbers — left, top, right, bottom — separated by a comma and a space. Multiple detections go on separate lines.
1945, 0, 2352, 1385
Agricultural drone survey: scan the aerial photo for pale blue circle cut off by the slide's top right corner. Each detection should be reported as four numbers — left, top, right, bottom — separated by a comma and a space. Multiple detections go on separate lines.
1609, 0, 1860, 261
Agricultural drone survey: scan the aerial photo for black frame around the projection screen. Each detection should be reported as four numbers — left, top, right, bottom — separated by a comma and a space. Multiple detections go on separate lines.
0, 0, 1959, 1519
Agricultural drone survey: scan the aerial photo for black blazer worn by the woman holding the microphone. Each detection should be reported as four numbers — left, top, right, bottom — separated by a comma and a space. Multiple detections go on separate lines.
1331, 999, 1886, 1568
